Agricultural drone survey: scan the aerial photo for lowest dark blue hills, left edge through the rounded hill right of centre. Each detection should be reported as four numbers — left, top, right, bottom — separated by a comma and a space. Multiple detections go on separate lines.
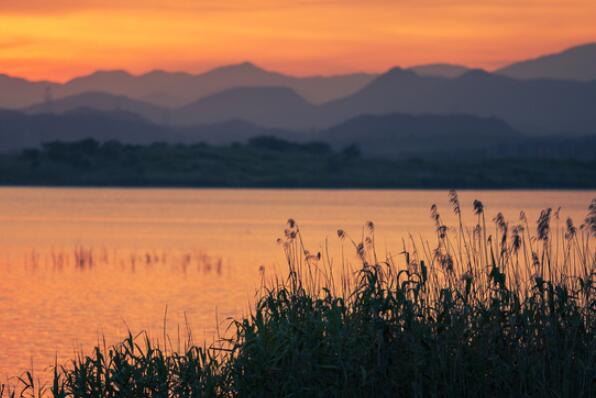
0, 108, 523, 157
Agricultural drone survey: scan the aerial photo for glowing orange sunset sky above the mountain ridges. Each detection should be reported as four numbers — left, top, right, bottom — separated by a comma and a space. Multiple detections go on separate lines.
0, 0, 596, 81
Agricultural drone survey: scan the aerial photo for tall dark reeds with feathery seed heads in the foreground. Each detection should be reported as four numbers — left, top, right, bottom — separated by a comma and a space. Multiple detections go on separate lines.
0, 191, 596, 397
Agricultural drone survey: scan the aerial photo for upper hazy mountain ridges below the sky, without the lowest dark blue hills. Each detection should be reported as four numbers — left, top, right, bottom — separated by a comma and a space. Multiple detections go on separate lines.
0, 44, 596, 136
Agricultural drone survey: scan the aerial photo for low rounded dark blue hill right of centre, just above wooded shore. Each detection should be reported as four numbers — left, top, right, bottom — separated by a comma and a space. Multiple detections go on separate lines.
317, 113, 522, 158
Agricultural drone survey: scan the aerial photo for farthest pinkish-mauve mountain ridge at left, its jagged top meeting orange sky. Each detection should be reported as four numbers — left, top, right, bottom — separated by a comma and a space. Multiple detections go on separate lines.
0, 62, 376, 109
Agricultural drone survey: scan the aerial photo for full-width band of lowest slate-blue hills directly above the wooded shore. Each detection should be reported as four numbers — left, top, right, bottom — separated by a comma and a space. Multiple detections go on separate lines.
0, 108, 596, 160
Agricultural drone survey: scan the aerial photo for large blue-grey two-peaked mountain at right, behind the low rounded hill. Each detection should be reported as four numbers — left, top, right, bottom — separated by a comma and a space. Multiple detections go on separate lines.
313, 68, 596, 135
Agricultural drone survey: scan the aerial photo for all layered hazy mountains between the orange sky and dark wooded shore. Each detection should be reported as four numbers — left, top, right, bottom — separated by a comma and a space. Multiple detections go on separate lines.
0, 44, 596, 155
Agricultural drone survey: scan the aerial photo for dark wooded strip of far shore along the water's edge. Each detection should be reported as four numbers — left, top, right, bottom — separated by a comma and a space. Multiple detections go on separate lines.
0, 136, 596, 188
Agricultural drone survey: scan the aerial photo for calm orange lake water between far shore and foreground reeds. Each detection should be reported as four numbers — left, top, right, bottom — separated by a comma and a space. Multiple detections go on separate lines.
0, 188, 596, 380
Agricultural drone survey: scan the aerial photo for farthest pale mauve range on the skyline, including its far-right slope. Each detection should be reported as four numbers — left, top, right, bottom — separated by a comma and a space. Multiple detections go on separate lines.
0, 43, 596, 109
